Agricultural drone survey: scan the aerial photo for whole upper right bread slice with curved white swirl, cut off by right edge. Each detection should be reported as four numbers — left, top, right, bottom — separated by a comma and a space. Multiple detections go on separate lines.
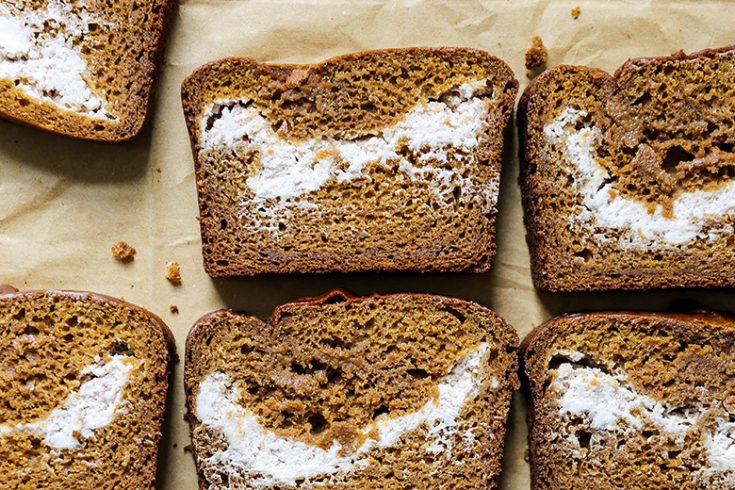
519, 47, 735, 291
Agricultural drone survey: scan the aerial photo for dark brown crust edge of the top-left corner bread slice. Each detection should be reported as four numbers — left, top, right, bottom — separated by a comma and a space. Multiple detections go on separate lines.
0, 0, 176, 143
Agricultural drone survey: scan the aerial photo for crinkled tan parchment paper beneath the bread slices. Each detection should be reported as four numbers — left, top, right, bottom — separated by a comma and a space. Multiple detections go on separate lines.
0, 0, 735, 489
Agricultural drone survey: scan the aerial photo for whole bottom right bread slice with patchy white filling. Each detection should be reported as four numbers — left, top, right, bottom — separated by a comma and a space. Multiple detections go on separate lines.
521, 312, 735, 490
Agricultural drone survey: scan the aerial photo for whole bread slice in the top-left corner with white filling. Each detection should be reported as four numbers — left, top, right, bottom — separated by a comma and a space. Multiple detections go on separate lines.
0, 0, 173, 141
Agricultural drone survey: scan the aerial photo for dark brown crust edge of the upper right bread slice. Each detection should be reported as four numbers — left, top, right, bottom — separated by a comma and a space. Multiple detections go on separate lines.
517, 45, 735, 292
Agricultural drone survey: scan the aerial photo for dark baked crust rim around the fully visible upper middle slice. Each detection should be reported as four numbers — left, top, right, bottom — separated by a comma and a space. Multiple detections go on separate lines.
181, 47, 518, 278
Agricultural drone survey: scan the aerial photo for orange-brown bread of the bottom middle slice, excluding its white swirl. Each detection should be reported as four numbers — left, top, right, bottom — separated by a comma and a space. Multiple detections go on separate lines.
185, 293, 517, 489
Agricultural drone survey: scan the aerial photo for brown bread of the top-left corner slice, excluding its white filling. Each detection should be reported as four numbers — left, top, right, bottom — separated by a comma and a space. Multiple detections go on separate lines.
0, 0, 175, 142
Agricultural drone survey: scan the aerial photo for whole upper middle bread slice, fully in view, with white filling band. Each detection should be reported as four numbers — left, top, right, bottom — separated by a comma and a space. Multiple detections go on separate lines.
182, 48, 518, 277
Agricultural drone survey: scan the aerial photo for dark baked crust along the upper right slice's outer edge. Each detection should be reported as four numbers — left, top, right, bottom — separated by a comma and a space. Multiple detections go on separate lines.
517, 44, 735, 293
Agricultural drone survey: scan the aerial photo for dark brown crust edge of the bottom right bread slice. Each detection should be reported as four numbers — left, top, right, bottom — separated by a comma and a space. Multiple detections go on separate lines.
519, 311, 735, 490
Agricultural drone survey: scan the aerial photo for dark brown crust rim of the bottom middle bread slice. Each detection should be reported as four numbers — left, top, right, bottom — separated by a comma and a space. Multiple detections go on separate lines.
184, 289, 520, 490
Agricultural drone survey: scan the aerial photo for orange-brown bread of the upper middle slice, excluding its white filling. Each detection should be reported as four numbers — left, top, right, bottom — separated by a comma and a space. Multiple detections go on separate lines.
182, 48, 517, 277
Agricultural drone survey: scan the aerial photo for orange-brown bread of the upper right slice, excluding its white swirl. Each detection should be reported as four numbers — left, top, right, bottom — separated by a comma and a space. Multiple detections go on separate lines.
519, 48, 735, 291
